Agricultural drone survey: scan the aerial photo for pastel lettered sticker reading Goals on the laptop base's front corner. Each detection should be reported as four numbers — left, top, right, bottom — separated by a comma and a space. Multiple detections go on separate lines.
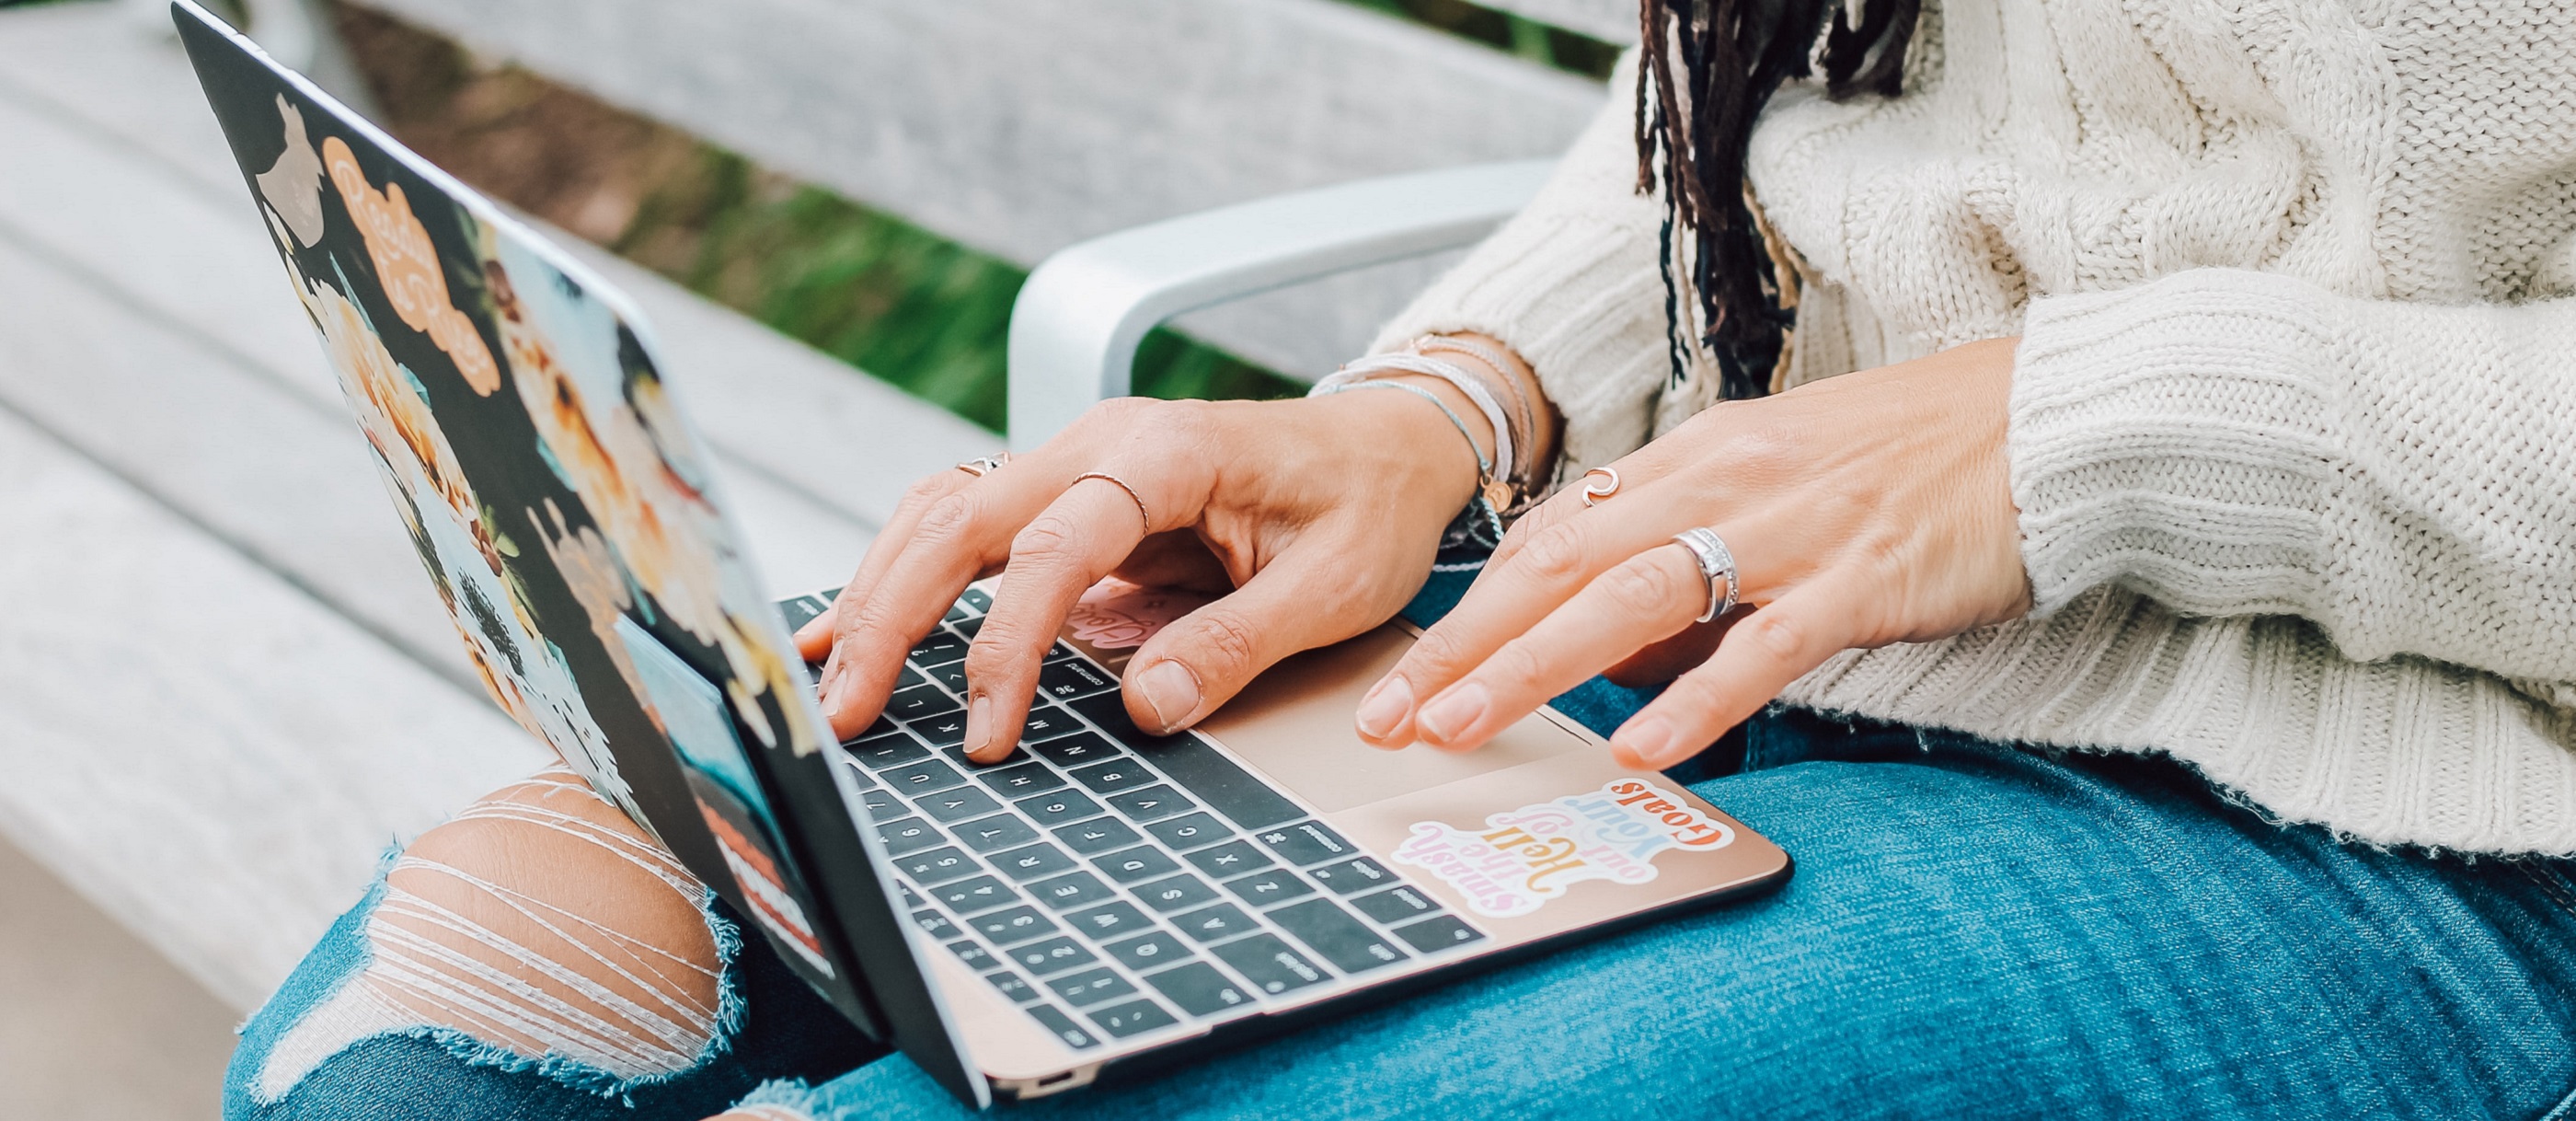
1394, 779, 1736, 918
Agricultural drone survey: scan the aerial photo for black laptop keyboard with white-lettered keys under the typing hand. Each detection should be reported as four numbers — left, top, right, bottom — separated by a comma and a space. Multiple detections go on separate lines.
780, 590, 1487, 1049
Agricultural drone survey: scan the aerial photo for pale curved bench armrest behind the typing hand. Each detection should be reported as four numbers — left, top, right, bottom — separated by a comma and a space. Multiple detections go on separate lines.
1010, 160, 1556, 451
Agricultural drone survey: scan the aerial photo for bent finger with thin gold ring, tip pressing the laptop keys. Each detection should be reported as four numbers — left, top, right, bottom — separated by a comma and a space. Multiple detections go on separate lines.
943, 471, 1172, 763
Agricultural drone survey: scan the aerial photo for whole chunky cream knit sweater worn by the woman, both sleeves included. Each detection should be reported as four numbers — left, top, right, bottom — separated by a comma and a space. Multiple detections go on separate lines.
1384, 0, 2576, 853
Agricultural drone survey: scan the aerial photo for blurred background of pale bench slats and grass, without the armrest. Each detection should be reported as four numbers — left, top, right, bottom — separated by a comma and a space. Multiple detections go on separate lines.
0, 0, 1636, 1121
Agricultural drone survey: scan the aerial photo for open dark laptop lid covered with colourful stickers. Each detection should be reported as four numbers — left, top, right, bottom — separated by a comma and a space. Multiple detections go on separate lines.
173, 0, 992, 1105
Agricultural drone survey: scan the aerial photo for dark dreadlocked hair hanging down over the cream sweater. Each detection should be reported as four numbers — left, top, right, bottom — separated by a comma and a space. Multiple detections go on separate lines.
1636, 0, 1922, 399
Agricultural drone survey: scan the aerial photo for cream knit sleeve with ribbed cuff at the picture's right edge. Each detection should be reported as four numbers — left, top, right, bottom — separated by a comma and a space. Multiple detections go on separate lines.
2009, 268, 2576, 696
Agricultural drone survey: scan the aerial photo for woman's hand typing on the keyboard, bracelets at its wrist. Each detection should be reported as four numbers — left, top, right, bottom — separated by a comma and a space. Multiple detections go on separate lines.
796, 384, 1491, 763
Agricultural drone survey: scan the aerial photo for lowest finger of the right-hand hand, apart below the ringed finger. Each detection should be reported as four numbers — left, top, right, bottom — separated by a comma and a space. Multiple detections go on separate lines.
1610, 580, 1860, 770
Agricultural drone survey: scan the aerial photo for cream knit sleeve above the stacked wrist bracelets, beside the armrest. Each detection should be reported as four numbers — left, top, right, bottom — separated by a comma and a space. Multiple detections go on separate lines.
1373, 52, 1669, 471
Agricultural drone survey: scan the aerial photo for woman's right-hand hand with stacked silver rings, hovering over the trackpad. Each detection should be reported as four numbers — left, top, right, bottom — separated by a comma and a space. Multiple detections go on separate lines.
1358, 338, 2030, 768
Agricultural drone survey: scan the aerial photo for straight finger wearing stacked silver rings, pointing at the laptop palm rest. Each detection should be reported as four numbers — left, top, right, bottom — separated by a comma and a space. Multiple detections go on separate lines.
1414, 544, 1708, 750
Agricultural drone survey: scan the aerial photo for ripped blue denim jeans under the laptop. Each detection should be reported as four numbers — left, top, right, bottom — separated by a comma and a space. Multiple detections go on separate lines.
224, 574, 2576, 1121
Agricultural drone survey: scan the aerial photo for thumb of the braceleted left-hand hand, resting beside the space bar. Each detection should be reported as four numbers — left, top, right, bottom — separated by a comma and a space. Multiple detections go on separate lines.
1126, 538, 1404, 732
